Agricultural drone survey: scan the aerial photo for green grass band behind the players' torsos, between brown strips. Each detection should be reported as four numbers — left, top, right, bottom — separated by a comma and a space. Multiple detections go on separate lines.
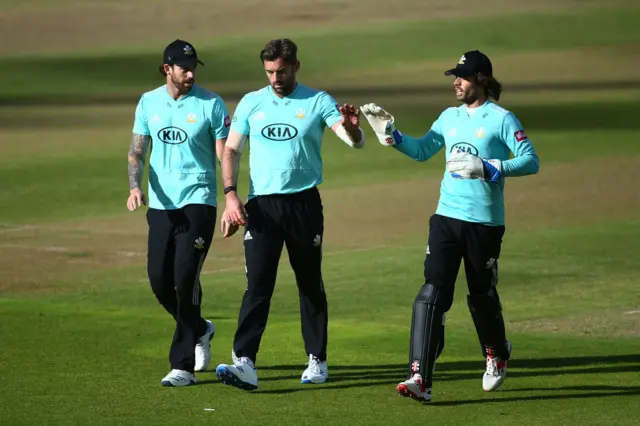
0, 100, 640, 223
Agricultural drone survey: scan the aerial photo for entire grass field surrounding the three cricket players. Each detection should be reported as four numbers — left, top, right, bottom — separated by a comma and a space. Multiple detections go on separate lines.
0, 0, 640, 425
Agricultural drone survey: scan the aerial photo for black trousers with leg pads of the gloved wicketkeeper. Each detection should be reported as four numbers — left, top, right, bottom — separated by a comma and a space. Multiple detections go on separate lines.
409, 214, 509, 386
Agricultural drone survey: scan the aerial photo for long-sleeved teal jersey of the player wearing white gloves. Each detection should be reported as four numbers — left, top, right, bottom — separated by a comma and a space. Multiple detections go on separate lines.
394, 101, 539, 226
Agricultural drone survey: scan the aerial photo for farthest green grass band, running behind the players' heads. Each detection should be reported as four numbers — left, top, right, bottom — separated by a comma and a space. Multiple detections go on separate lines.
0, 9, 640, 102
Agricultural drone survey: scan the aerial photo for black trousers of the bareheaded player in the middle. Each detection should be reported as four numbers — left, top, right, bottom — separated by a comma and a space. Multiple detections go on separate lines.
233, 188, 328, 362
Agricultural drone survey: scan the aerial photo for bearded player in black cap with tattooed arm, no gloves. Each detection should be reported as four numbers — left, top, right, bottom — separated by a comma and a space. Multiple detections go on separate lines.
127, 40, 231, 386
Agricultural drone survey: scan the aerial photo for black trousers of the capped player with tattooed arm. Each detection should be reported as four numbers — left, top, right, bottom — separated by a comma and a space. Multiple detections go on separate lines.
147, 204, 216, 373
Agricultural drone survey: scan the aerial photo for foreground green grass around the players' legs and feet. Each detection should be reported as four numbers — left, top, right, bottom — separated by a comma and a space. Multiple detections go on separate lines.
0, 222, 640, 424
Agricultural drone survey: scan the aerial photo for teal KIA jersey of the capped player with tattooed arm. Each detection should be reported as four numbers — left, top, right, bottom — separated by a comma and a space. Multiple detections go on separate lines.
133, 84, 231, 210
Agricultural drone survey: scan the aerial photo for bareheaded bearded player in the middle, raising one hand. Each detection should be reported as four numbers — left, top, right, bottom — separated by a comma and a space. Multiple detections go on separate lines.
216, 39, 365, 390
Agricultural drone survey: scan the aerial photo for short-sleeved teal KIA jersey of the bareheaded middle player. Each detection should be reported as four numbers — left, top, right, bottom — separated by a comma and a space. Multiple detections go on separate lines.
231, 84, 342, 198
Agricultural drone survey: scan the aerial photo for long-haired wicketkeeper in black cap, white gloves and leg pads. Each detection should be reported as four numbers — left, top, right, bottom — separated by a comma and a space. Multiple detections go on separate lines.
361, 50, 539, 401
